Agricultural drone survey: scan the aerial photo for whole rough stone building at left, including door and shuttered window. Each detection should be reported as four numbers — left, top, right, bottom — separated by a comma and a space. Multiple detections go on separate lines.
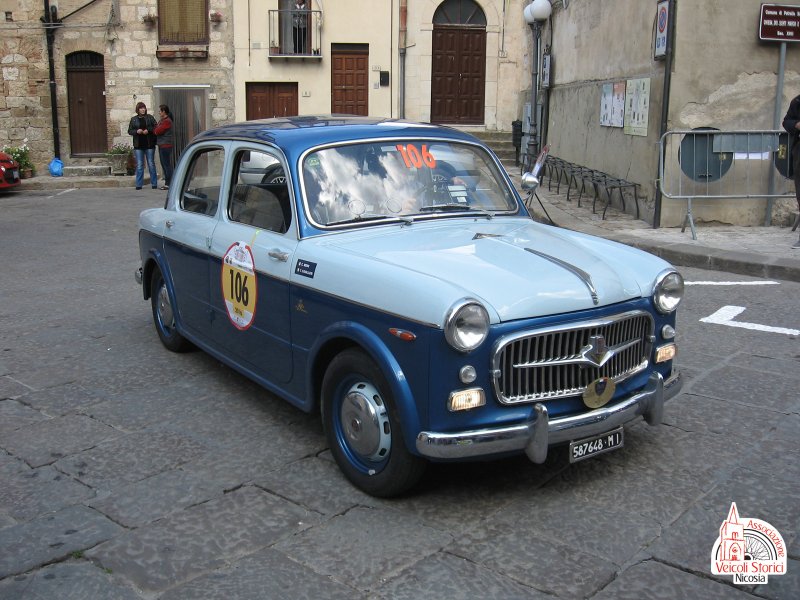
0, 0, 234, 173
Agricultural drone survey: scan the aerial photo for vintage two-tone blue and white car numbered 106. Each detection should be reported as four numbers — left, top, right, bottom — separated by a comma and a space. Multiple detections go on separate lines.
136, 117, 683, 496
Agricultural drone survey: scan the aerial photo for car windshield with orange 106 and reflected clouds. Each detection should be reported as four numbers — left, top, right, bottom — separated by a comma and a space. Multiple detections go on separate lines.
303, 140, 517, 227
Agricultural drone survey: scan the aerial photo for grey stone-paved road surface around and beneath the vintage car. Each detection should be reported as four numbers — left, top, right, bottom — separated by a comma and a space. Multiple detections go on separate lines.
0, 189, 800, 600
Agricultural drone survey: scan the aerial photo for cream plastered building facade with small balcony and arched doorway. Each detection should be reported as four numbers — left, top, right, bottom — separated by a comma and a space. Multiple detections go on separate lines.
233, 0, 530, 131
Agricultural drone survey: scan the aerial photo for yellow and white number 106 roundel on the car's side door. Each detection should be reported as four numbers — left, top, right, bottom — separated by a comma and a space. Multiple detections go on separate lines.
222, 242, 257, 330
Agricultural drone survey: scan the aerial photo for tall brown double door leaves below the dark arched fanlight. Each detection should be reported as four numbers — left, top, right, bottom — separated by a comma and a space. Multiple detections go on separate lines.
431, 26, 486, 124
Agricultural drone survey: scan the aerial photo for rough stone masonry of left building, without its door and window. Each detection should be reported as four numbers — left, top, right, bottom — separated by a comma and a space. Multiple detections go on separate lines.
0, 0, 234, 173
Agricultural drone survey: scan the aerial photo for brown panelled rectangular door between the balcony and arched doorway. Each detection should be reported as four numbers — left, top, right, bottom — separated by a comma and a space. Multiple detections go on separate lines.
331, 49, 369, 116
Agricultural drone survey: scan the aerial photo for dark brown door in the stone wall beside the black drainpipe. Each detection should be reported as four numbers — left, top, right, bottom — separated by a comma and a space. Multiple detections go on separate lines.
66, 52, 108, 156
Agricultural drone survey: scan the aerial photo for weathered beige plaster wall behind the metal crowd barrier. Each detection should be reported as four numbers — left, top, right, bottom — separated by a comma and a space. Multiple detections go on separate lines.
542, 0, 800, 226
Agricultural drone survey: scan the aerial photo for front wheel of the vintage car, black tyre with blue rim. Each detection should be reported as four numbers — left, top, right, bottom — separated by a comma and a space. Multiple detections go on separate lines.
322, 350, 426, 498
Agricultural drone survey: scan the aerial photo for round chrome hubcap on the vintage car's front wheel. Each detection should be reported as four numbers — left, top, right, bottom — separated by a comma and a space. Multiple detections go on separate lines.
339, 382, 392, 462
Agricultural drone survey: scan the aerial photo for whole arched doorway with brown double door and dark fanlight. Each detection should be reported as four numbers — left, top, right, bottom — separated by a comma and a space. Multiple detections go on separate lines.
431, 0, 486, 125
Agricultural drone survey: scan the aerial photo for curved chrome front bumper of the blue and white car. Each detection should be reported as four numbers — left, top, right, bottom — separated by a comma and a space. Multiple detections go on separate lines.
417, 373, 683, 463
